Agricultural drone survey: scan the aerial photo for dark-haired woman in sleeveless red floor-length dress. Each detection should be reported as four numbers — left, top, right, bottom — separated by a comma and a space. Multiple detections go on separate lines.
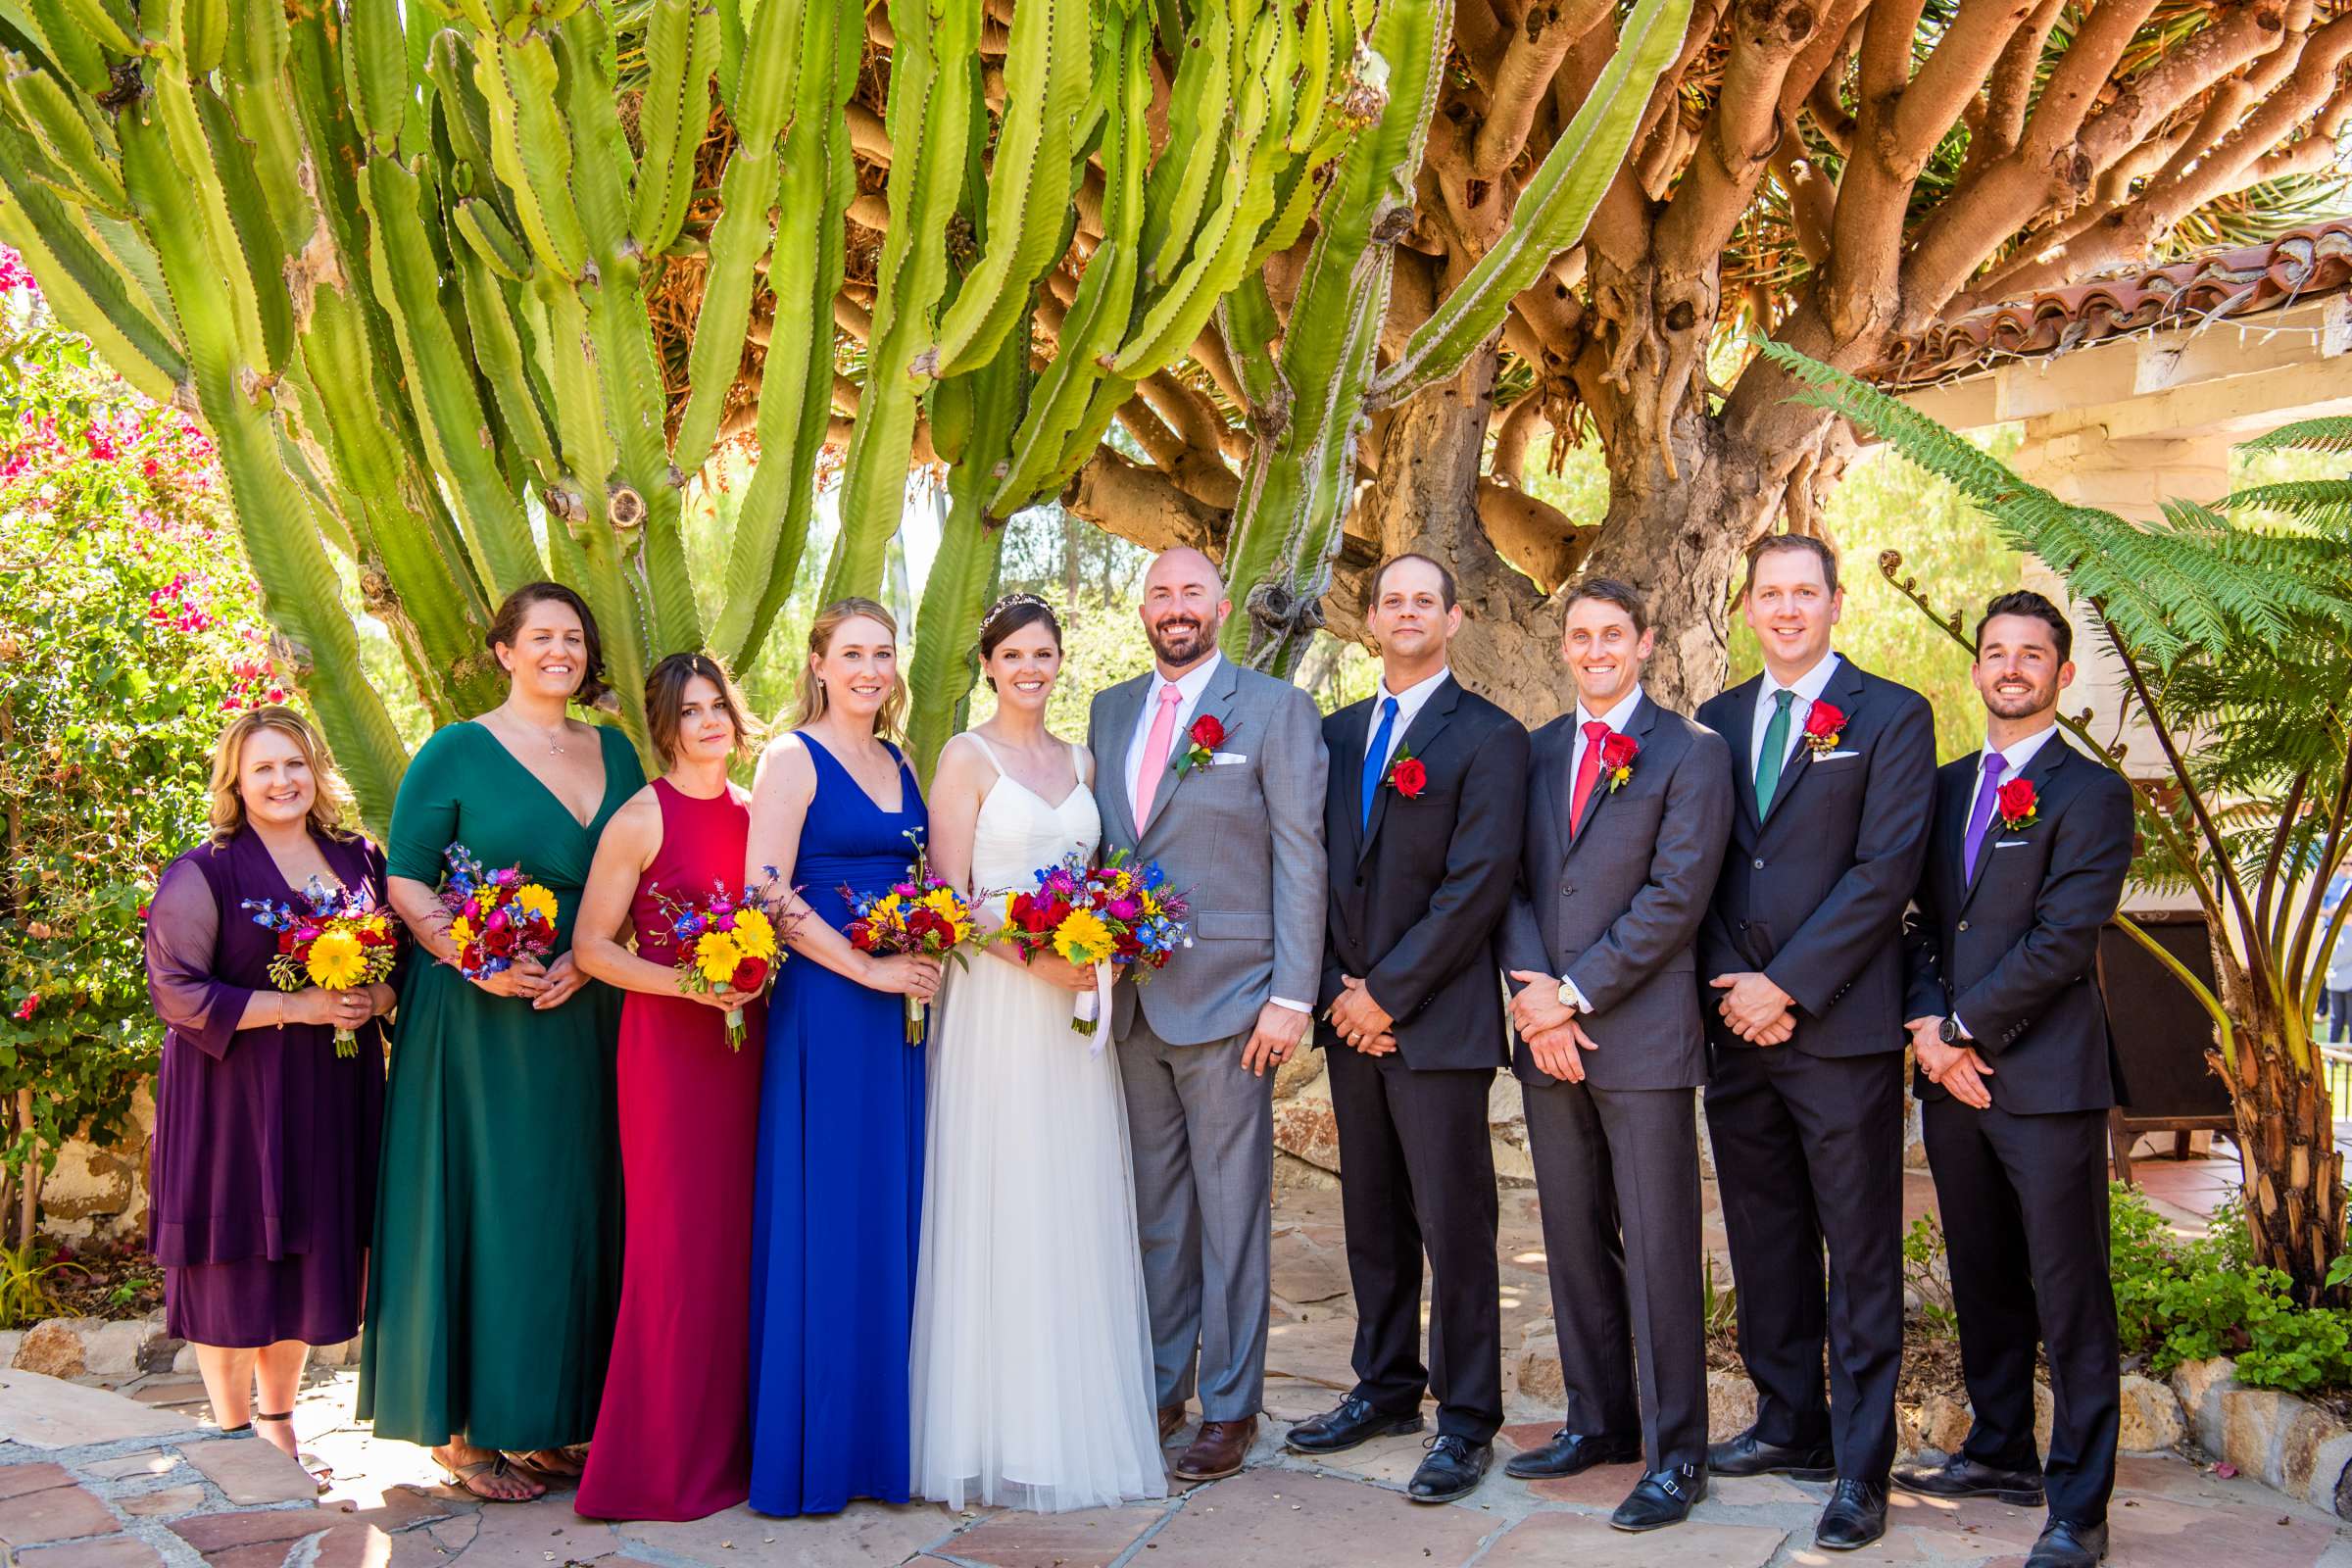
571, 654, 764, 1521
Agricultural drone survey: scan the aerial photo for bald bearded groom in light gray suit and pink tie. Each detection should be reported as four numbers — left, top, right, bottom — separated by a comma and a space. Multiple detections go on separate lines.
1087, 550, 1327, 1481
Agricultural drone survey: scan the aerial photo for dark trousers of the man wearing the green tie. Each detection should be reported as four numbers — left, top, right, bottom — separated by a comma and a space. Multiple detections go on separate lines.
1707, 1046, 1903, 1486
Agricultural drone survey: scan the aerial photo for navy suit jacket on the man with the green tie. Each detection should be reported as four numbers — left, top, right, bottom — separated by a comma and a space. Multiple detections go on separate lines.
1698, 659, 1936, 1055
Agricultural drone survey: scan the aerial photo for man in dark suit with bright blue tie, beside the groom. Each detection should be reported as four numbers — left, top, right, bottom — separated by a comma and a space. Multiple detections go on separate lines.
1289, 555, 1527, 1502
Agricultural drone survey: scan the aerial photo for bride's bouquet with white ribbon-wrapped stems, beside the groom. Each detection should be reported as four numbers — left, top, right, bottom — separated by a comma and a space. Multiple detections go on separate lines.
998, 849, 1193, 1051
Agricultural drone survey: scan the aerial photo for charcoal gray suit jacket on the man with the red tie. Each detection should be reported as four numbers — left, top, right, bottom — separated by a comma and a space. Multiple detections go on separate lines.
1503, 696, 1731, 1089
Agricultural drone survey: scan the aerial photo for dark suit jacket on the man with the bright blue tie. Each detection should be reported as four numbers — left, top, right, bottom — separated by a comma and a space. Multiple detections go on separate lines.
1315, 674, 1527, 1072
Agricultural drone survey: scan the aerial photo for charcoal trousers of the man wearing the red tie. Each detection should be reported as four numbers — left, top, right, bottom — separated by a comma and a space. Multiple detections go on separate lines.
1524, 1084, 1707, 1469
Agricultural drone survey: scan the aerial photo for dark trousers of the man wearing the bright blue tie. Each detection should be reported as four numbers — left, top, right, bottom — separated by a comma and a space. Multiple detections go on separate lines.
1324, 1046, 1503, 1444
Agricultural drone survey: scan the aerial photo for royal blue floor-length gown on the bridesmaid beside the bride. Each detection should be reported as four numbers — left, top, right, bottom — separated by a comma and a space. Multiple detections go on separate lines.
751, 731, 927, 1514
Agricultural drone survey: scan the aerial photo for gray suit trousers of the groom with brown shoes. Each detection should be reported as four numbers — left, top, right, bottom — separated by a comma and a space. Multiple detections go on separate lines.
1119, 1008, 1275, 1420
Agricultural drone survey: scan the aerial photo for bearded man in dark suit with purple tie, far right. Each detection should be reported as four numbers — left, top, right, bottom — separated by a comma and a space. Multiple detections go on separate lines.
1895, 592, 2131, 1568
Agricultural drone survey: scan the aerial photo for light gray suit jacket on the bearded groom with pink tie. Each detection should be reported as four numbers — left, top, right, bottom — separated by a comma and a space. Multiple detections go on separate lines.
1087, 659, 1329, 1046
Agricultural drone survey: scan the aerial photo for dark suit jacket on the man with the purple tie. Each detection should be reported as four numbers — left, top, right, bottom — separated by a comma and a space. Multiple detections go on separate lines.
1905, 736, 2133, 1114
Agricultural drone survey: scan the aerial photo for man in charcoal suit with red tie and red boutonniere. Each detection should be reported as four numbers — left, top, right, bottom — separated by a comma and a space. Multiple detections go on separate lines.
1503, 578, 1731, 1531
